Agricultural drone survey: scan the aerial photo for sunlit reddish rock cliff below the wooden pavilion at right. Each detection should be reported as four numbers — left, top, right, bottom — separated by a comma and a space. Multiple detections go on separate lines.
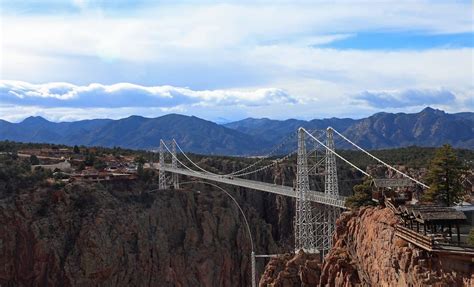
260, 207, 474, 287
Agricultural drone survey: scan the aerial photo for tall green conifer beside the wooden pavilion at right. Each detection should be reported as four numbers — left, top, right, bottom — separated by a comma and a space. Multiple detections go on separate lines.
423, 144, 465, 206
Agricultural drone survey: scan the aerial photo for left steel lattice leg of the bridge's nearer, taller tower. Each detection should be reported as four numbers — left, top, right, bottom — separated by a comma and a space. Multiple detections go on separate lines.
295, 128, 317, 253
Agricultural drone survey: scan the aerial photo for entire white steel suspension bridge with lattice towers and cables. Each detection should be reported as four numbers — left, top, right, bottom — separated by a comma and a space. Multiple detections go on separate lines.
153, 127, 428, 256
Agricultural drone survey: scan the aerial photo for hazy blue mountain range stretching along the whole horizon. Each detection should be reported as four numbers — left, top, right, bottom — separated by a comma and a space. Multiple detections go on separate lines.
0, 108, 474, 155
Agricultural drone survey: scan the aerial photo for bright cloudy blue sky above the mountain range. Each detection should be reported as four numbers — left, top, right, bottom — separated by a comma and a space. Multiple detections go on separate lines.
0, 0, 474, 122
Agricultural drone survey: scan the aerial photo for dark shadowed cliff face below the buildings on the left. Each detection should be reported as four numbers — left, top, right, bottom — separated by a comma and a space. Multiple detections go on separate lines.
0, 184, 284, 286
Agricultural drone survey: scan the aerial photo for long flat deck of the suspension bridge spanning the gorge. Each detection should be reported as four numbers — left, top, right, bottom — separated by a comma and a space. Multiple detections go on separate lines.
153, 164, 347, 209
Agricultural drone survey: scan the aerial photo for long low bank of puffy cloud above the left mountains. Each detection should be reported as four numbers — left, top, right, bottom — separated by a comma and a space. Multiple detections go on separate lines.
0, 80, 297, 110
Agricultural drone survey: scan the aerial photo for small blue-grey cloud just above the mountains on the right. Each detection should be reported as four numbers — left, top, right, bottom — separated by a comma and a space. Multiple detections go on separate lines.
355, 89, 456, 109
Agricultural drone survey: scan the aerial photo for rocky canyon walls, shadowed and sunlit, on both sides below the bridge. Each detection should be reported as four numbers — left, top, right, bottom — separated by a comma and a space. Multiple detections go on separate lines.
0, 150, 474, 287
